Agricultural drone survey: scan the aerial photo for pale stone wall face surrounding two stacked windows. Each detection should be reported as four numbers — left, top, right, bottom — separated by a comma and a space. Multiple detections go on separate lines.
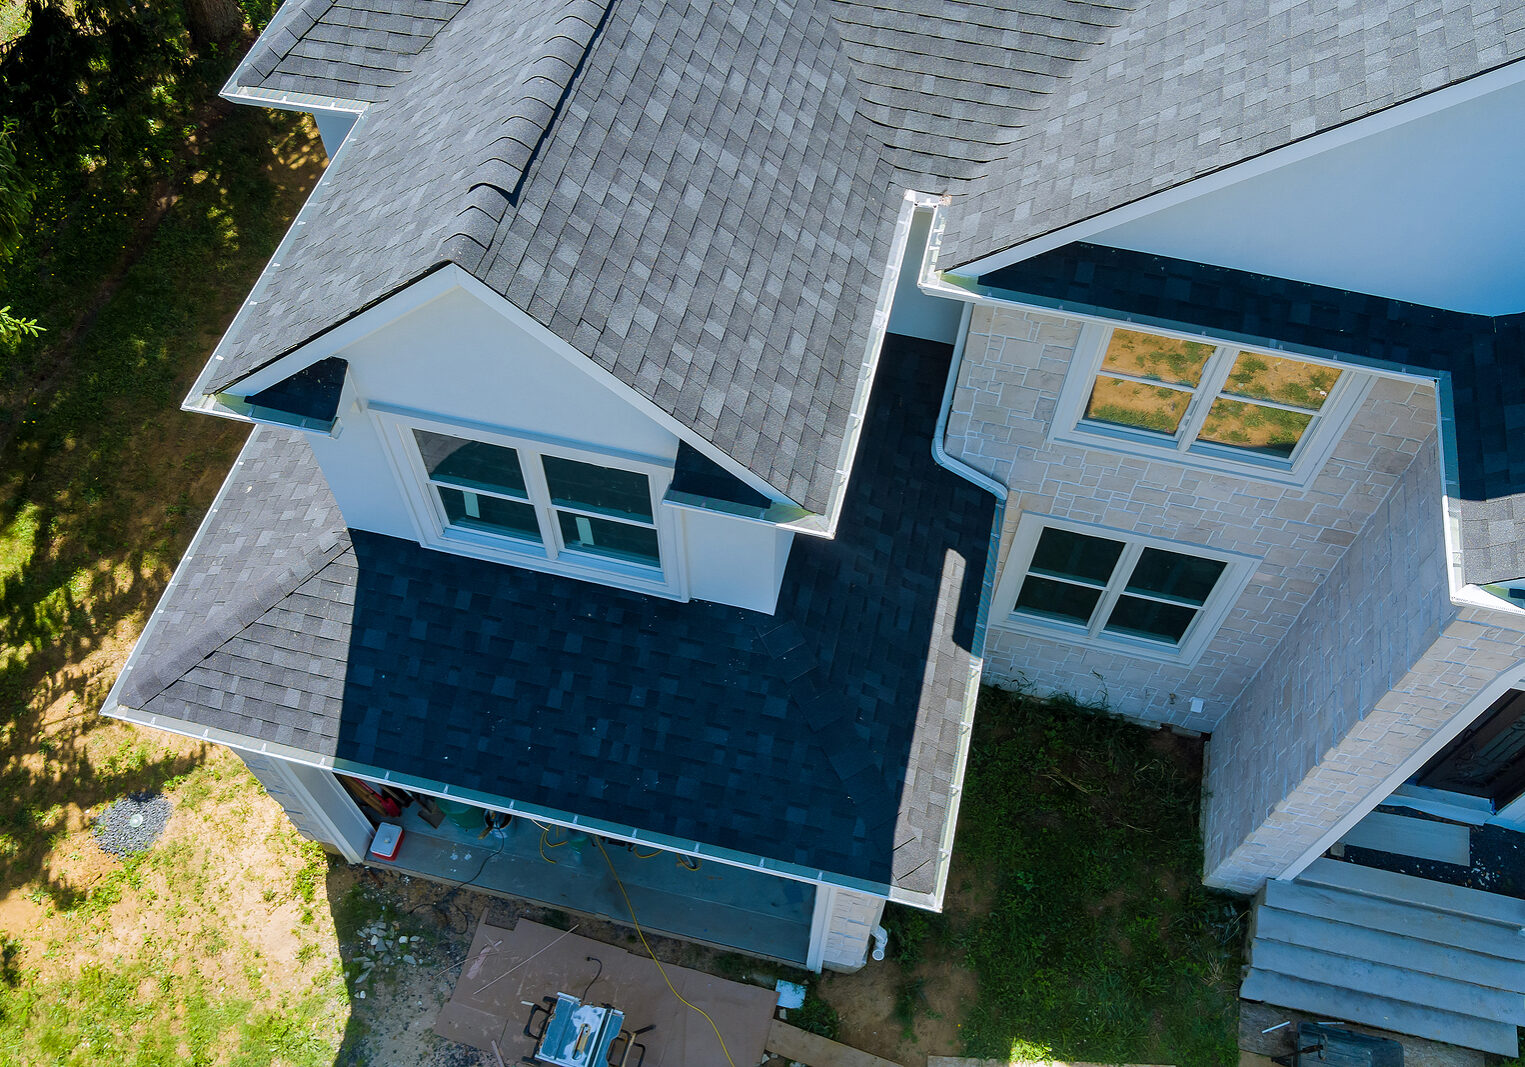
947, 306, 1440, 730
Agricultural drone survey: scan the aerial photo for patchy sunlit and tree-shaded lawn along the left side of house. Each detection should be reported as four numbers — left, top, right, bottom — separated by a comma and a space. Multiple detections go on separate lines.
0, 93, 348, 1064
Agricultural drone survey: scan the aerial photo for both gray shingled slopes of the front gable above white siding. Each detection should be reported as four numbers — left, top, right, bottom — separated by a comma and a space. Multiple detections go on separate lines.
212, 0, 894, 511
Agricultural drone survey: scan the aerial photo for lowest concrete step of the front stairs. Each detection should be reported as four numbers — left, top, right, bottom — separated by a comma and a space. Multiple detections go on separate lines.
1240, 968, 1519, 1056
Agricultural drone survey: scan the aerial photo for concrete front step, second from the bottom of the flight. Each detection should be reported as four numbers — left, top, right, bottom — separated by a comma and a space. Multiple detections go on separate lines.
1249, 937, 1525, 1026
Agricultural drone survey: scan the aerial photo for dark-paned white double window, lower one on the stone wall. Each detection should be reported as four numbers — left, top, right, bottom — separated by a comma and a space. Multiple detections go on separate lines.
996, 515, 1254, 658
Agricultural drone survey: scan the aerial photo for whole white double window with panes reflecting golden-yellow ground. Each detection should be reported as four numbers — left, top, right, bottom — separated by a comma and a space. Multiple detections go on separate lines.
1054, 323, 1363, 480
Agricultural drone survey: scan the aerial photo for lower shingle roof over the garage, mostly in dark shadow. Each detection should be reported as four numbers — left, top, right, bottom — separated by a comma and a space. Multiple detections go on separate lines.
116, 338, 999, 893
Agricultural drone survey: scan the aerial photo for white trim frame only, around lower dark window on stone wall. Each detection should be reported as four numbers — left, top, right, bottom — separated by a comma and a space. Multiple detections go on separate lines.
990, 512, 1260, 666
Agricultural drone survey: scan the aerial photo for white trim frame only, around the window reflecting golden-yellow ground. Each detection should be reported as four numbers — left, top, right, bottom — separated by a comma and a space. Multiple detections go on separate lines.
1049, 322, 1373, 486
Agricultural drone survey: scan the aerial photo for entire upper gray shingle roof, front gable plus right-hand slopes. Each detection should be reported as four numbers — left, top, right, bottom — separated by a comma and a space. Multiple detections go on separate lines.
209, 0, 1525, 512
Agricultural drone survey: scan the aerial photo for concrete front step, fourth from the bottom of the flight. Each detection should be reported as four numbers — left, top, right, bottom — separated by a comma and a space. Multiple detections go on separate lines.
1261, 864, 1525, 962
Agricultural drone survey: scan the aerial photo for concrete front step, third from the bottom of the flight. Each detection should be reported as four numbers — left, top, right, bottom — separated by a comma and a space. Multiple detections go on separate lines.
1255, 905, 1525, 994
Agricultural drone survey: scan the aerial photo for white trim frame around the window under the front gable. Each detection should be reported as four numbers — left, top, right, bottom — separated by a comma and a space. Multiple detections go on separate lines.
371, 405, 688, 601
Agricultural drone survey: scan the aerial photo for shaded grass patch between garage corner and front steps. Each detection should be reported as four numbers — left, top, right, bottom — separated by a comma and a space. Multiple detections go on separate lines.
820, 689, 1244, 1067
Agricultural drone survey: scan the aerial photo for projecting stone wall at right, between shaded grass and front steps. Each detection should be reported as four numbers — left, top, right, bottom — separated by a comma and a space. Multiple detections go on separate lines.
1205, 439, 1457, 892
